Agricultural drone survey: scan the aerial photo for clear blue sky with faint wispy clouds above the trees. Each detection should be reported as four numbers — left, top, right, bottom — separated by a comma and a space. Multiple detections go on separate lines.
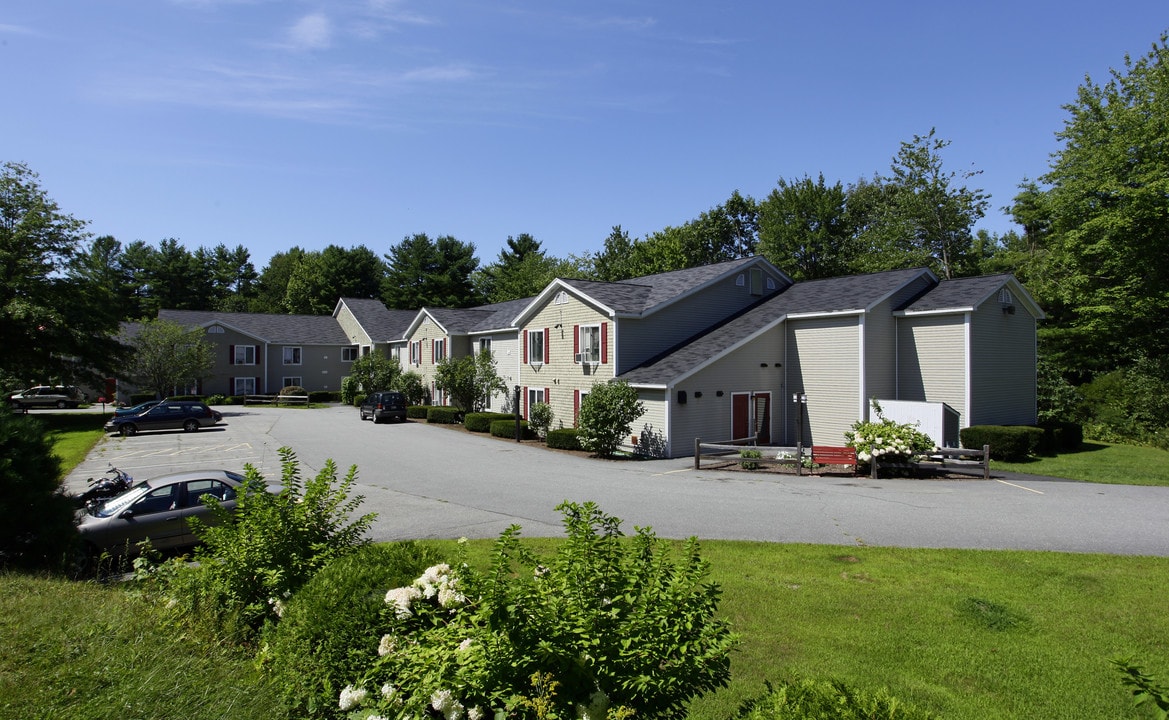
0, 0, 1169, 269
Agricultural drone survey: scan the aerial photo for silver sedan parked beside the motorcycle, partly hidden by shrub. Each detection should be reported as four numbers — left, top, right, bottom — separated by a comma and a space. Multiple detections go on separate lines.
77, 470, 258, 555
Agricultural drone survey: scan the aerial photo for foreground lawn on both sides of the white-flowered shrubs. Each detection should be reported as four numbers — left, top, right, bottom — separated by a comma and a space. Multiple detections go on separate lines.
0, 539, 1169, 720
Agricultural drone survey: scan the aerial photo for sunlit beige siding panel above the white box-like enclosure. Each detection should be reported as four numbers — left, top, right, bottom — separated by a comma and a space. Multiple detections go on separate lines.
894, 313, 970, 420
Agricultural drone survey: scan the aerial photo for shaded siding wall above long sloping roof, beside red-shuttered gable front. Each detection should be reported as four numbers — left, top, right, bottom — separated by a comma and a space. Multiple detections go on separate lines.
617, 270, 783, 374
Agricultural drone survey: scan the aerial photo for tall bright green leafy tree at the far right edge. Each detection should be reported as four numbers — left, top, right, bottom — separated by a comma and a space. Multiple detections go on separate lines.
1012, 35, 1169, 380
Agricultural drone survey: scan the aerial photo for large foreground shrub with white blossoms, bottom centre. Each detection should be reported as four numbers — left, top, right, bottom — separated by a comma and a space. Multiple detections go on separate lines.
338, 503, 736, 720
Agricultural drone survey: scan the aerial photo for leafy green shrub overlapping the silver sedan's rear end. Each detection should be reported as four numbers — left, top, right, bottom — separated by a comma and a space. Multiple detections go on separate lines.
154, 448, 374, 638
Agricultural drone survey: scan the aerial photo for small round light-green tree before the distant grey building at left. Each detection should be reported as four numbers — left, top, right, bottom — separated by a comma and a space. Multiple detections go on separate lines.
130, 318, 215, 397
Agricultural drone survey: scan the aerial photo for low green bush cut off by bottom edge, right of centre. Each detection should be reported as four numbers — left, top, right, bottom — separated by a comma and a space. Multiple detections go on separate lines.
735, 679, 934, 720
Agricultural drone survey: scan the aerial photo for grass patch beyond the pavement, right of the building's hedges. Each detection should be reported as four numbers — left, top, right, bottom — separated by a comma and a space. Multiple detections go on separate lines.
990, 441, 1169, 486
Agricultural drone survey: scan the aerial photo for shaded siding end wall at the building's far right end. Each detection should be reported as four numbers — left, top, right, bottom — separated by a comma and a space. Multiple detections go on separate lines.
967, 302, 1036, 425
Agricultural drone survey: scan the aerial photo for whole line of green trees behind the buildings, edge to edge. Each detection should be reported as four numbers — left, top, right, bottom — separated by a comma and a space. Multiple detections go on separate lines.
0, 35, 1169, 444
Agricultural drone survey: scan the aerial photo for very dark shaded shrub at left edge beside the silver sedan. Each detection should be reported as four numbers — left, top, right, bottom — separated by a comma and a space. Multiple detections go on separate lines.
0, 407, 77, 568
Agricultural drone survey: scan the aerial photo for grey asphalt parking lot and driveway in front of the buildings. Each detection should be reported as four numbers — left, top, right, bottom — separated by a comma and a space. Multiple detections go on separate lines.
68, 406, 1169, 556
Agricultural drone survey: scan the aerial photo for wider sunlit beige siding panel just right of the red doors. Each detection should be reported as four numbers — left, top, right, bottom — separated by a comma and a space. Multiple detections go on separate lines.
780, 316, 862, 445
